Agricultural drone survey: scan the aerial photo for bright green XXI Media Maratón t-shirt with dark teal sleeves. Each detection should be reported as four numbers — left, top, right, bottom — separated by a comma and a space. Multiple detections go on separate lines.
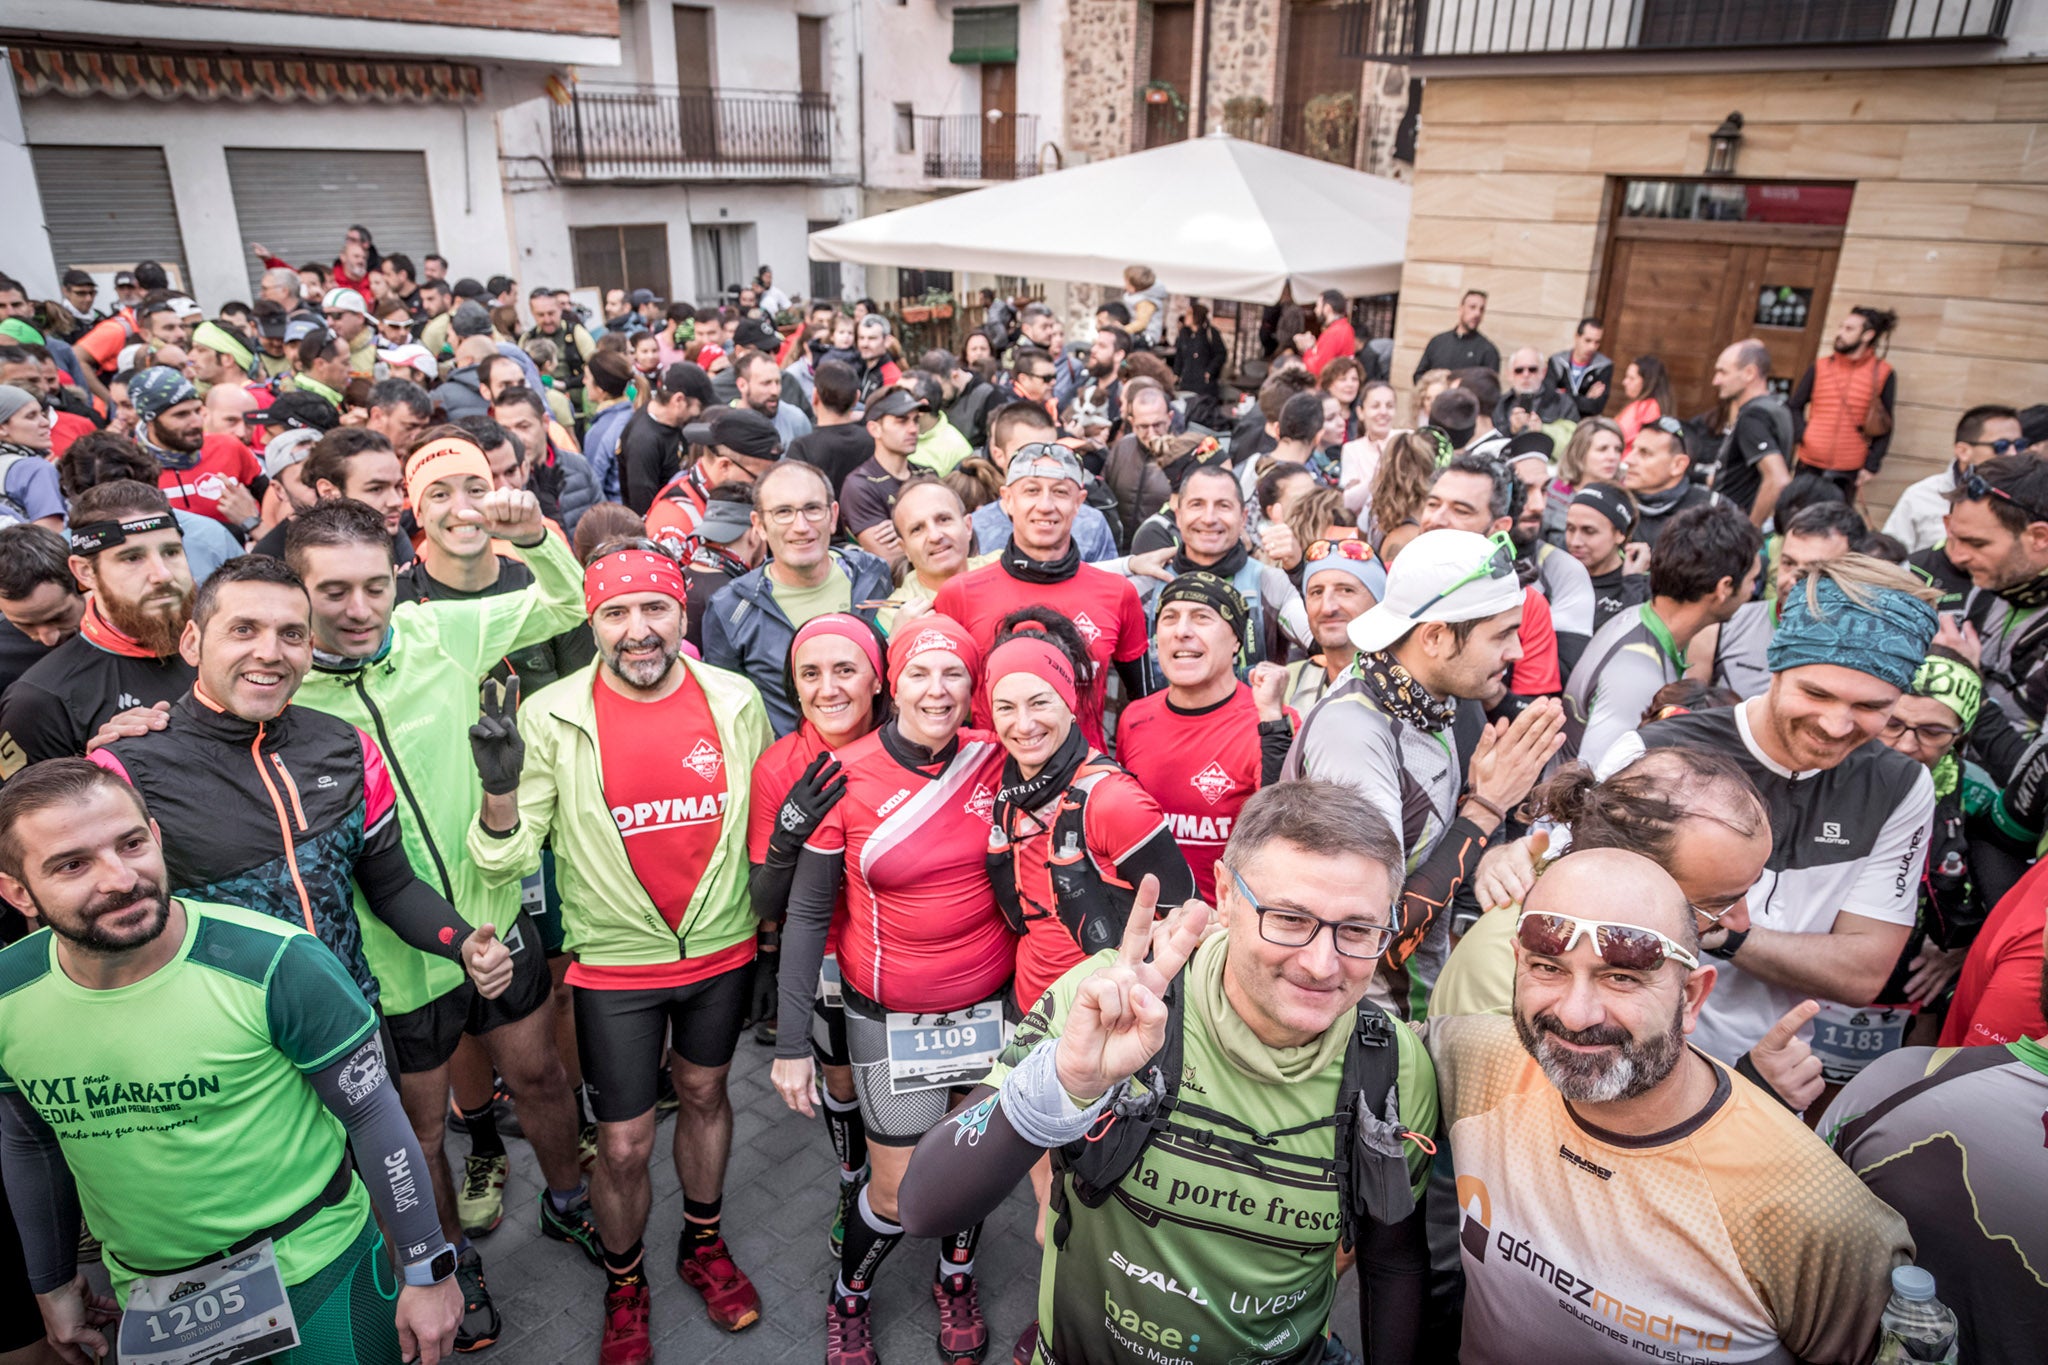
0, 900, 377, 1302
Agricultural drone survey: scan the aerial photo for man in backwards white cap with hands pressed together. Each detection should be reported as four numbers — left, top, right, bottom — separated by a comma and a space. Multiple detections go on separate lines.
1280, 530, 1565, 1015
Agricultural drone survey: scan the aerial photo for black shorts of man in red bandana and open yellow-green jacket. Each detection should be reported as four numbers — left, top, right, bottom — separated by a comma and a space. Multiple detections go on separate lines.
573, 962, 754, 1124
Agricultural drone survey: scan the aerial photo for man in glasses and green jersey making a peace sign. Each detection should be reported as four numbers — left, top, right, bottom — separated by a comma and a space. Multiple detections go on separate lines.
897, 780, 1436, 1365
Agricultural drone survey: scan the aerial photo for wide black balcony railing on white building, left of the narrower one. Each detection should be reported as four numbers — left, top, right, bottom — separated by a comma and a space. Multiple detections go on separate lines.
549, 86, 831, 180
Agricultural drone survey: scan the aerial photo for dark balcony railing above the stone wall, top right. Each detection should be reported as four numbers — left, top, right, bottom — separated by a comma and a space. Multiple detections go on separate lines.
1343, 0, 2011, 61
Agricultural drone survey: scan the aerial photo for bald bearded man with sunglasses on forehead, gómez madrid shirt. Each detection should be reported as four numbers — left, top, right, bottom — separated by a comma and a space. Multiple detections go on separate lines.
1397, 847, 1913, 1365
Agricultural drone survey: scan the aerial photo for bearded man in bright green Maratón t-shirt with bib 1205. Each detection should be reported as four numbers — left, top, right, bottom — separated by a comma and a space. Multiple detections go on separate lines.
0, 759, 463, 1365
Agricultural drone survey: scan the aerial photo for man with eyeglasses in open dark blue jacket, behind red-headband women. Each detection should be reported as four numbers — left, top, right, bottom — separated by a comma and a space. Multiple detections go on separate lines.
702, 462, 893, 737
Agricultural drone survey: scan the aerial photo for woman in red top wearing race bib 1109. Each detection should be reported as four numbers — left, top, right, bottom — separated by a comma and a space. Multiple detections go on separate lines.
774, 616, 1016, 1365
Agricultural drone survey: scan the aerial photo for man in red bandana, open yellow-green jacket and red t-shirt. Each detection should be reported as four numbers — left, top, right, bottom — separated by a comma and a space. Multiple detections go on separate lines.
469, 548, 770, 1365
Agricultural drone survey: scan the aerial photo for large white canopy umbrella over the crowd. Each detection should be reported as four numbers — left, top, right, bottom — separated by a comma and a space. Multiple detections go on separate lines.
811, 133, 1409, 303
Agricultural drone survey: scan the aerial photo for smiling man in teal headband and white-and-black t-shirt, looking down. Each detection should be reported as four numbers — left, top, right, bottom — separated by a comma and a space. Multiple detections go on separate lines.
1597, 555, 1935, 1081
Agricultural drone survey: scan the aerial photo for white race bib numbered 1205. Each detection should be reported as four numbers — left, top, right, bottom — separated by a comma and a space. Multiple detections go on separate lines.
121, 1238, 299, 1365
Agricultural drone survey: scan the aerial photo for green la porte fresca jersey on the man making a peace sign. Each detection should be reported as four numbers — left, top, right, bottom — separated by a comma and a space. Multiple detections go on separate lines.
989, 935, 1436, 1365
